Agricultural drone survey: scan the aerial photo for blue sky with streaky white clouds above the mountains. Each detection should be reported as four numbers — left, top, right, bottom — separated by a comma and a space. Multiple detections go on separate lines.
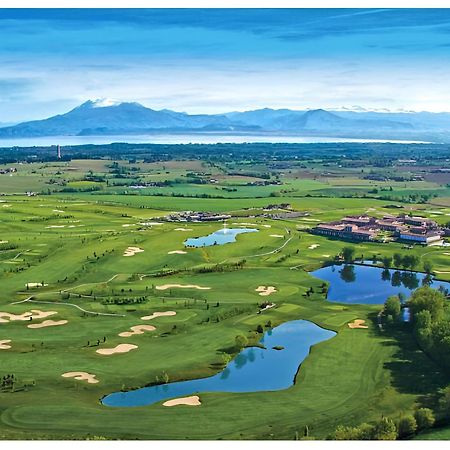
0, 9, 450, 123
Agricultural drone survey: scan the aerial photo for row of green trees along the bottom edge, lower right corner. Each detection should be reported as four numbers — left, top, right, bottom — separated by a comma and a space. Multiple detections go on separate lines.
331, 408, 435, 441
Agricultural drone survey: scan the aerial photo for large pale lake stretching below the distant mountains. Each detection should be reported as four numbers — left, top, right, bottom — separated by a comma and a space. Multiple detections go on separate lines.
0, 133, 423, 148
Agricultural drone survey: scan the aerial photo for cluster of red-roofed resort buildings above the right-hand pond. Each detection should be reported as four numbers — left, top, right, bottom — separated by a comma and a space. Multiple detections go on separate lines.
311, 214, 450, 245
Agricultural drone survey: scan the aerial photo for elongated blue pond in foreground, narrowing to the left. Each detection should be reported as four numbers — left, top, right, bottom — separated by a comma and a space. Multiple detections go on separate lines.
102, 320, 336, 407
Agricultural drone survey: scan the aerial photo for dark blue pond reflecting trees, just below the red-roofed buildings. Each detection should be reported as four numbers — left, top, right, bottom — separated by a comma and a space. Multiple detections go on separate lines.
311, 264, 450, 304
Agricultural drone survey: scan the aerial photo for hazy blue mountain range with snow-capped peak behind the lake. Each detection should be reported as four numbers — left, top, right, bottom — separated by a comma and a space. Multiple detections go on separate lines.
0, 100, 450, 142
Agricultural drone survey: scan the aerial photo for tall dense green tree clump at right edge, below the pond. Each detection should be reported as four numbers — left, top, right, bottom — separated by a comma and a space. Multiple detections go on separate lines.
408, 286, 450, 369
